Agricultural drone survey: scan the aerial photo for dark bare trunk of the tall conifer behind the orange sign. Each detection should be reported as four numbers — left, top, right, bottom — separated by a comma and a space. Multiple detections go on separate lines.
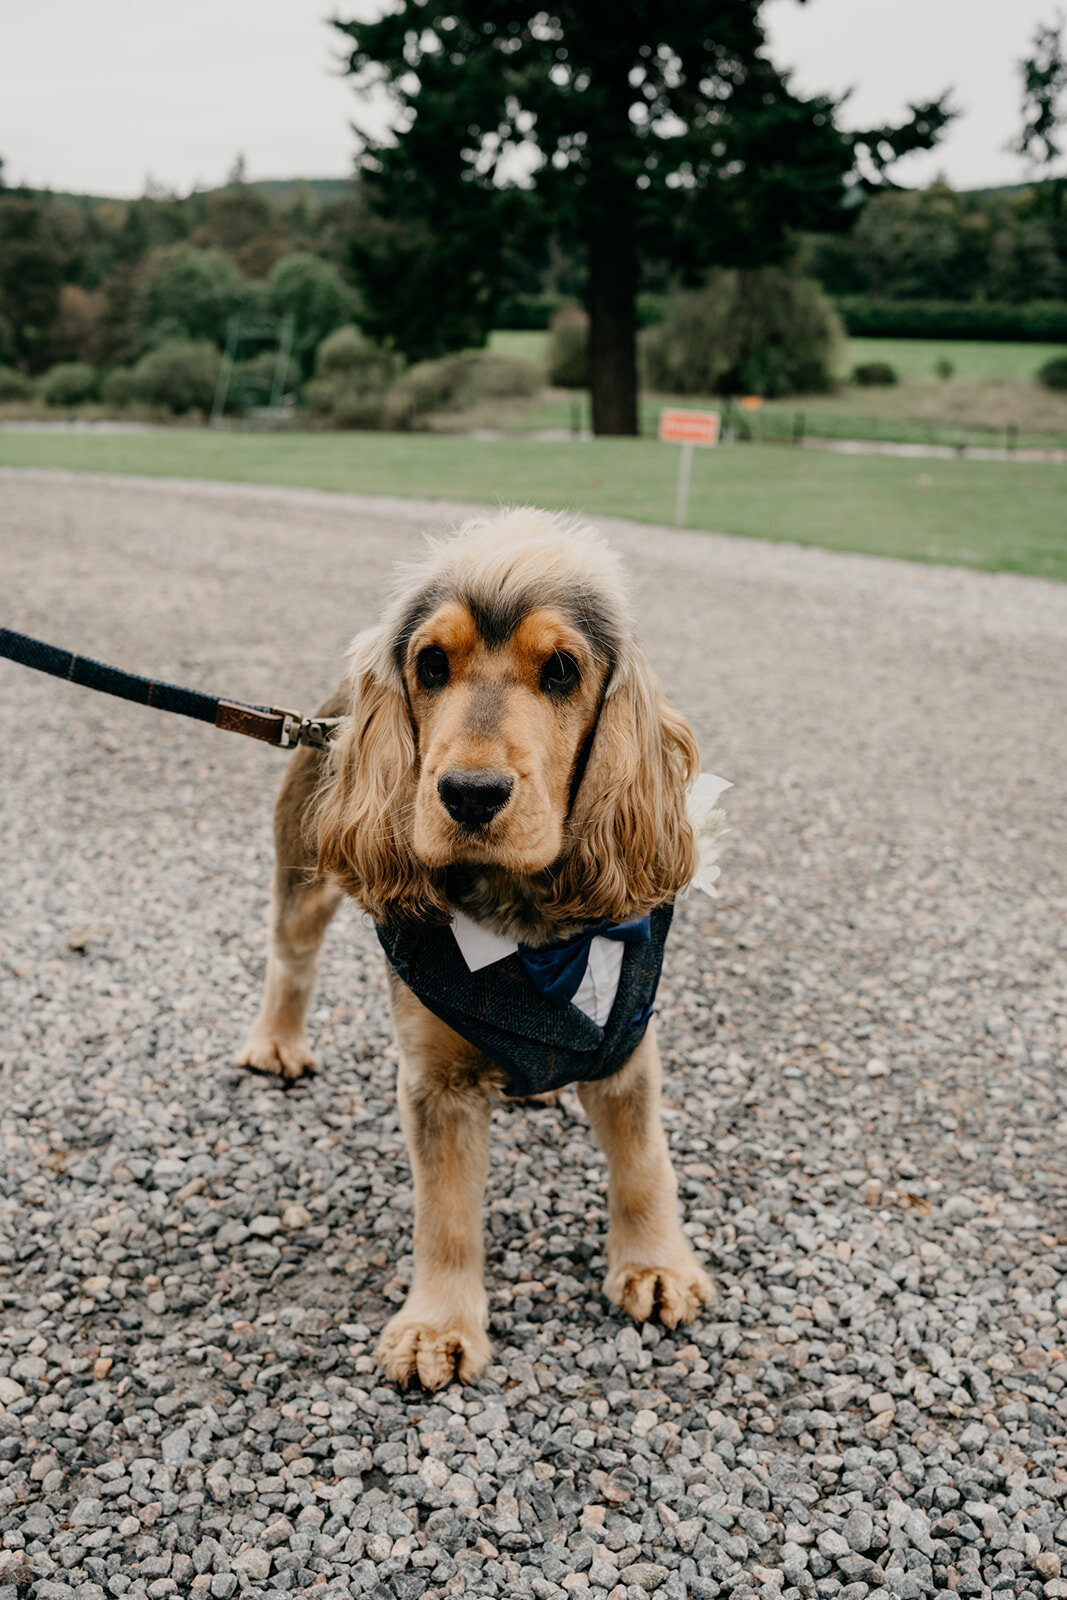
589, 212, 638, 438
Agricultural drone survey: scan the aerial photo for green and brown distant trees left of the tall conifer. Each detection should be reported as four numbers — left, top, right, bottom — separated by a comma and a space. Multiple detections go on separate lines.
0, 163, 358, 374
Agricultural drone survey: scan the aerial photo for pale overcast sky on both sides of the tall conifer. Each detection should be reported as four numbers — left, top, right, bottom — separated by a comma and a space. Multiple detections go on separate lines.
0, 0, 1056, 195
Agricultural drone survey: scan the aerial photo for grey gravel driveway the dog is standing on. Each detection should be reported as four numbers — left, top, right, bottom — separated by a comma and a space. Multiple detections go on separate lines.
0, 472, 1067, 1600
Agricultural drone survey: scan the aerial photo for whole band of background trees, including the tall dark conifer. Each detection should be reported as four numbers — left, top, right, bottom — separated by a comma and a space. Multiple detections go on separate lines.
0, 0, 1067, 434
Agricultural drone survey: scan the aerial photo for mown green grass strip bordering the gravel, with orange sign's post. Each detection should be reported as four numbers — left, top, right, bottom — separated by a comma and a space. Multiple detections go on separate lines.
0, 427, 1067, 579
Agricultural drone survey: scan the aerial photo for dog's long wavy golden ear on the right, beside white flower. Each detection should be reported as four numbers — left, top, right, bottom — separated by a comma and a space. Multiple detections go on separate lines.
552, 648, 701, 923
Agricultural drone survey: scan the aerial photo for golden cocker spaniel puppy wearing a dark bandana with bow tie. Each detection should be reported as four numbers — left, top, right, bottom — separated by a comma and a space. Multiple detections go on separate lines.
238, 510, 710, 1389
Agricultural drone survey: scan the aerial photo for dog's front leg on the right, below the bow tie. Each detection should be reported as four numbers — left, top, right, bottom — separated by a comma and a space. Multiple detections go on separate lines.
577, 1027, 712, 1328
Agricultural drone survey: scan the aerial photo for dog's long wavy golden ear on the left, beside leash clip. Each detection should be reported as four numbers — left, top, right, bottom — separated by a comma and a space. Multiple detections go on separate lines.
315, 632, 448, 925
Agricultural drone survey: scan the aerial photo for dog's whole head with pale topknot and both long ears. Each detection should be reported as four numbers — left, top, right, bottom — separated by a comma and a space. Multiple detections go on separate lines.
318, 510, 699, 925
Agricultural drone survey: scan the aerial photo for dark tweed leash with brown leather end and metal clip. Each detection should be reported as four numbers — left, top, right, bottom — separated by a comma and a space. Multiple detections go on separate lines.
0, 627, 341, 750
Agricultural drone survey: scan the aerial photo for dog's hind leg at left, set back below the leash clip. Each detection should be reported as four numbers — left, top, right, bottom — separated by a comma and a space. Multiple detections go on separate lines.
237, 732, 342, 1078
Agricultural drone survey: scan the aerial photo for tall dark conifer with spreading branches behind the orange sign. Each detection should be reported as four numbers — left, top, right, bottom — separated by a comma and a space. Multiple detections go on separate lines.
338, 0, 950, 434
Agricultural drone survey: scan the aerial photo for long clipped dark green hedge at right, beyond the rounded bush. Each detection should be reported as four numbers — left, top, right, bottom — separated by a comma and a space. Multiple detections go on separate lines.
835, 294, 1067, 344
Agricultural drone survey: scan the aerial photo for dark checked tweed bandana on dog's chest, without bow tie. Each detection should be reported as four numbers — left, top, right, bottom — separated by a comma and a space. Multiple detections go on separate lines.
378, 906, 673, 1096
